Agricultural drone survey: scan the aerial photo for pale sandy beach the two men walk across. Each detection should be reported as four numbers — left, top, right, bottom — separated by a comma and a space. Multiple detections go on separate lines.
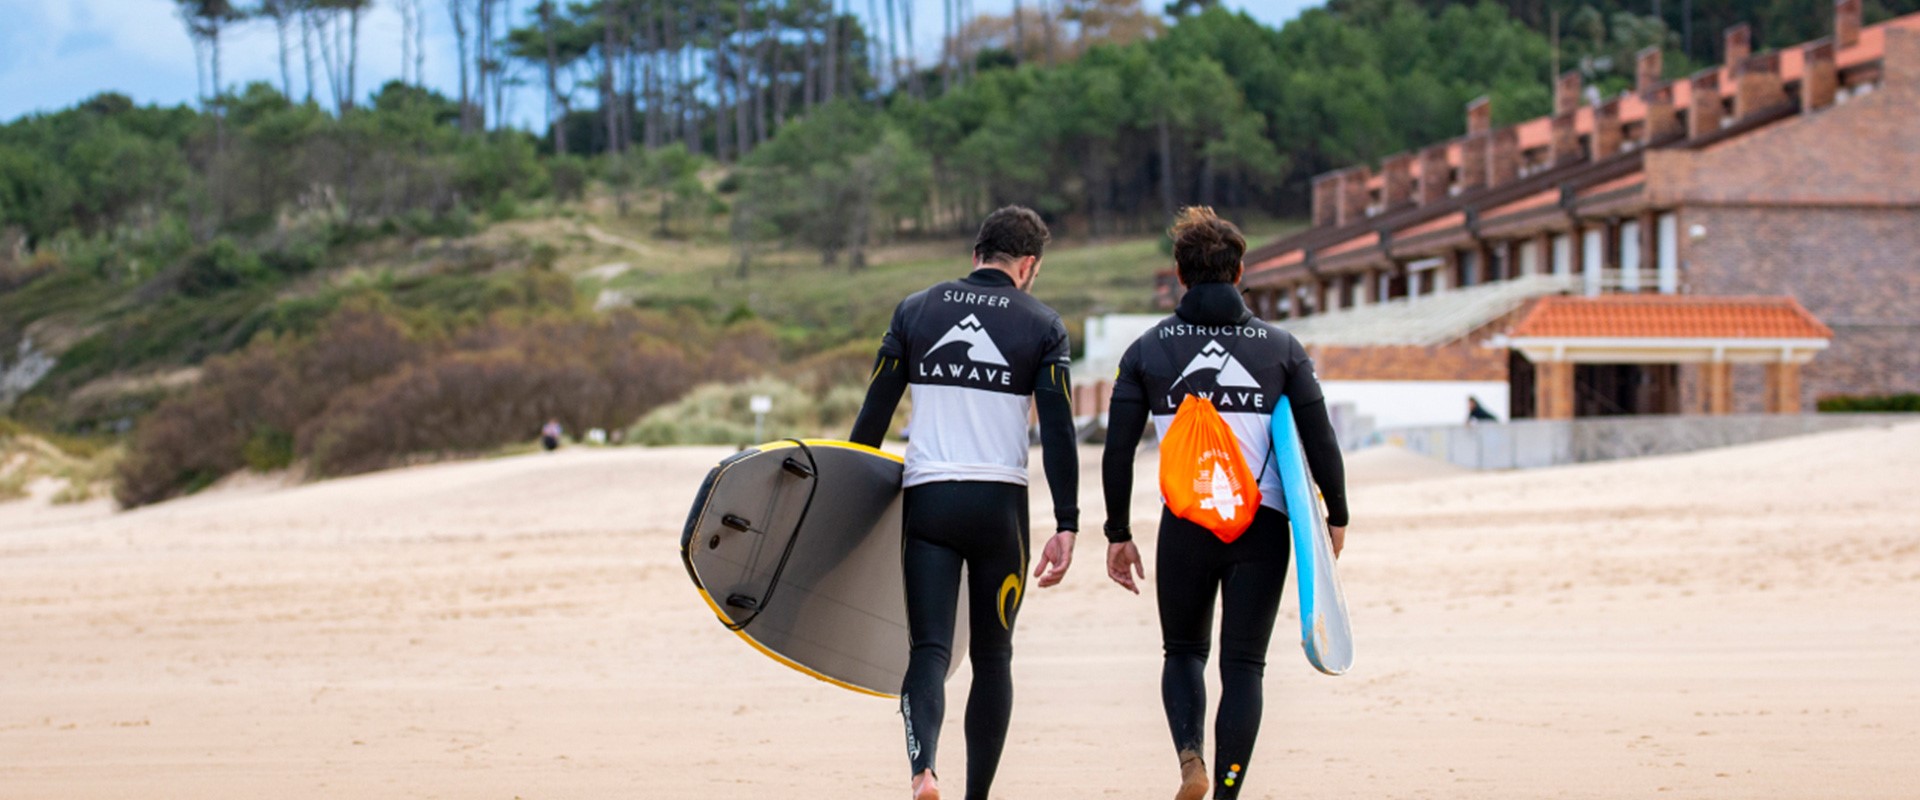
0, 426, 1920, 800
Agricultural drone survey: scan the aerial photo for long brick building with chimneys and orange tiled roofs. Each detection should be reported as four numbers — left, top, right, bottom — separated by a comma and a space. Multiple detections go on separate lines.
1228, 0, 1920, 416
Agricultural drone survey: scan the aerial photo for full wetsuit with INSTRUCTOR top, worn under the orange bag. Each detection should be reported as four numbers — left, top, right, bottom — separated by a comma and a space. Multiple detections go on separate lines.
1100, 284, 1348, 800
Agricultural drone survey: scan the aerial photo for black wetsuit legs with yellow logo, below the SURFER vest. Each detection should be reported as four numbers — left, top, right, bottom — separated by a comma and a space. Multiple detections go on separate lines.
900, 482, 1029, 800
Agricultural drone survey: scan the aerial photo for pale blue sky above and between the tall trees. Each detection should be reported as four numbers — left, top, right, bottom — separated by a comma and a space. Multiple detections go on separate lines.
0, 0, 1319, 125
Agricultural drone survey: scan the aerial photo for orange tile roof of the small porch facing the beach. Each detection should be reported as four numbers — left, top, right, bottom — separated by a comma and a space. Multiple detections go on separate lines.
1507, 294, 1834, 340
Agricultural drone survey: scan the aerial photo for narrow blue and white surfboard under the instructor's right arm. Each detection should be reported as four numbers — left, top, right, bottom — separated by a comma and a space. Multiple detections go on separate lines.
1273, 397, 1354, 675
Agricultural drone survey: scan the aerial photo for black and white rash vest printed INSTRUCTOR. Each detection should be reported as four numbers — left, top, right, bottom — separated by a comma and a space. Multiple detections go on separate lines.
1114, 284, 1323, 512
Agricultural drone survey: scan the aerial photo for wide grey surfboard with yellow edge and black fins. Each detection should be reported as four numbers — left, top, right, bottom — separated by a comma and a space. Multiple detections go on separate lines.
680, 439, 966, 696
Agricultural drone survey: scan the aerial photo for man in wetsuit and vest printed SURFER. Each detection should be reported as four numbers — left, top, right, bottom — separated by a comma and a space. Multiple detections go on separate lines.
851, 205, 1079, 800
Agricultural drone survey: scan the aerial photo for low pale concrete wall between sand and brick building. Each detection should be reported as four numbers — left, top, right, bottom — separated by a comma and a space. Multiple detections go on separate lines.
1377, 414, 1920, 470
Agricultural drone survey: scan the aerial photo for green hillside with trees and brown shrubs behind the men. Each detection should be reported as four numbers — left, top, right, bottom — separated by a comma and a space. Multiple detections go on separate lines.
11, 0, 1858, 503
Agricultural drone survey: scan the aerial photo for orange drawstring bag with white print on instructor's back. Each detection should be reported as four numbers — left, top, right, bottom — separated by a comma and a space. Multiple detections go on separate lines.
1160, 395, 1260, 543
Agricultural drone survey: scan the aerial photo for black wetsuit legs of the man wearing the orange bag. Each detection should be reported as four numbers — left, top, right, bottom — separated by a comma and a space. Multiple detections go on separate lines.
1156, 506, 1292, 800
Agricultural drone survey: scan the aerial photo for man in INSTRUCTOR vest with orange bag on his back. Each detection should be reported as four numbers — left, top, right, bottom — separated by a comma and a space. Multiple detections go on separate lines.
1100, 209, 1348, 800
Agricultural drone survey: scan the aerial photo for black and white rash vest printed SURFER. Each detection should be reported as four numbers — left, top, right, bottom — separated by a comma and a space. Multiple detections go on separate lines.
879, 271, 1071, 485
